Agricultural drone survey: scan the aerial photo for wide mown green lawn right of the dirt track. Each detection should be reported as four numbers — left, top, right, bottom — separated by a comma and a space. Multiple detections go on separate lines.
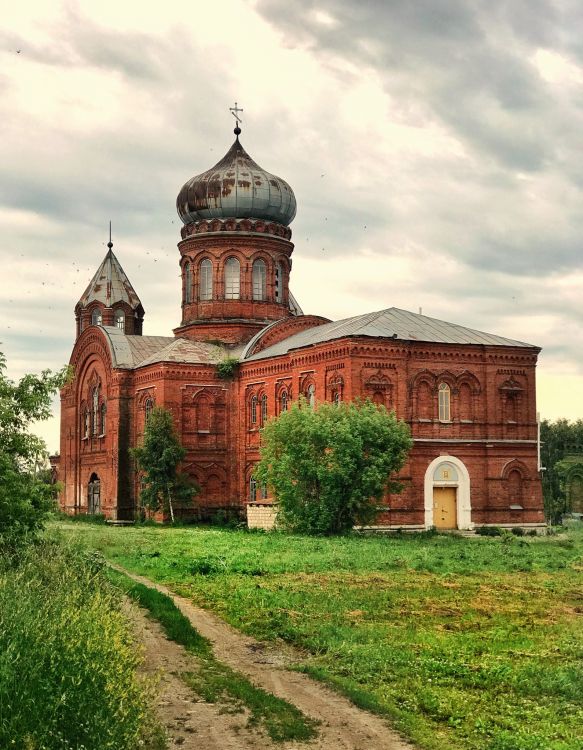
58, 524, 583, 750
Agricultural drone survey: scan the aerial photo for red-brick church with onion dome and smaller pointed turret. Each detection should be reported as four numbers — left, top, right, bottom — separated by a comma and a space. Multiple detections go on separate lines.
57, 113, 544, 530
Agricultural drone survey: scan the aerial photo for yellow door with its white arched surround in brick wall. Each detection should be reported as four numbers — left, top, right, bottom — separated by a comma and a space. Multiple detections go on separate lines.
425, 456, 473, 529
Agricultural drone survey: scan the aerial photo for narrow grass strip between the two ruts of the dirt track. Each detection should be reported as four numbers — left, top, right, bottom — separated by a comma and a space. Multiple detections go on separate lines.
110, 570, 317, 742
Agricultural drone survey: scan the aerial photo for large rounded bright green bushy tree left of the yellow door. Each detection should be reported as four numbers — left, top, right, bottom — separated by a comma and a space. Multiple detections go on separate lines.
254, 399, 412, 534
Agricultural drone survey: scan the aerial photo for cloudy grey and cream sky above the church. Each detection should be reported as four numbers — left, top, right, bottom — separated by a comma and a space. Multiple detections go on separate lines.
0, 0, 583, 451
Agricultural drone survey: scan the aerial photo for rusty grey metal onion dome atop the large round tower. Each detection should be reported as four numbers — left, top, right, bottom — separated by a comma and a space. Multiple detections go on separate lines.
176, 127, 296, 226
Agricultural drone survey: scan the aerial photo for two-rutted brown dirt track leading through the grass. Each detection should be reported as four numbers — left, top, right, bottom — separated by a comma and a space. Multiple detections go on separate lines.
113, 566, 413, 750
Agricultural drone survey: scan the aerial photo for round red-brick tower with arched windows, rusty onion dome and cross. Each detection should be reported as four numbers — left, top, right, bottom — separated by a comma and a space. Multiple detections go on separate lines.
174, 118, 302, 344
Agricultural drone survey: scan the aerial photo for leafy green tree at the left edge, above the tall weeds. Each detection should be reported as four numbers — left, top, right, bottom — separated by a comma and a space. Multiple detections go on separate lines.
0, 353, 68, 548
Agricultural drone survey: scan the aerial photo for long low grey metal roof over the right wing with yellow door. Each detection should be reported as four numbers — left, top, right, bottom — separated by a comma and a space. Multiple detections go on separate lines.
243, 307, 538, 361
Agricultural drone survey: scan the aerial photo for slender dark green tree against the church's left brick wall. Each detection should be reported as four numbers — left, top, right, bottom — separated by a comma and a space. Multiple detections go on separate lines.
131, 406, 196, 521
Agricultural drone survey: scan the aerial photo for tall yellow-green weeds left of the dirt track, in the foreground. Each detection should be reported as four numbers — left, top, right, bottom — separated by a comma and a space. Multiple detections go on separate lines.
0, 543, 160, 750
